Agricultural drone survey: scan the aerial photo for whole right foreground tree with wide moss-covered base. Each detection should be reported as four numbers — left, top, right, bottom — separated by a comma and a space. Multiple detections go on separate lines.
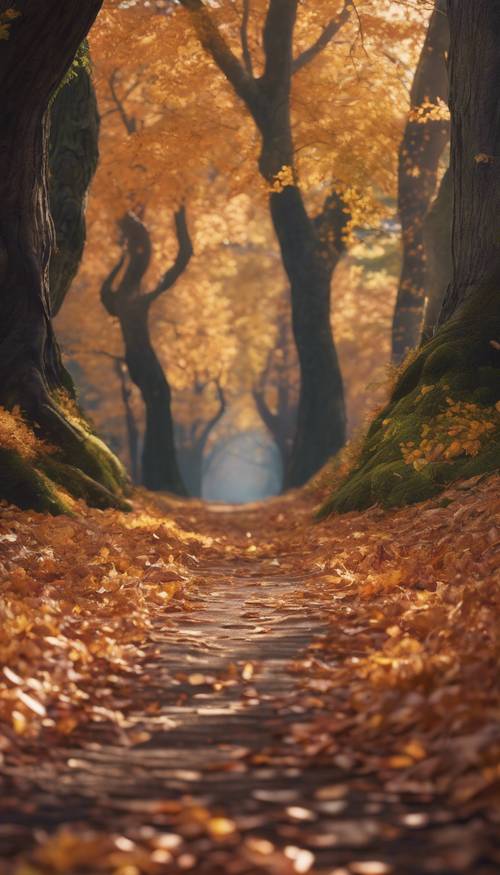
323, 0, 500, 513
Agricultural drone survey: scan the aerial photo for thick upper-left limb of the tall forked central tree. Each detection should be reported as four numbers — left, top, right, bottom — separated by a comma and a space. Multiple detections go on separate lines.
180, 0, 258, 108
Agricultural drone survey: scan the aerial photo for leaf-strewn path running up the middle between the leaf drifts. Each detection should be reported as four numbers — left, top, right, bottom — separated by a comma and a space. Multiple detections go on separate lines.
0, 492, 497, 875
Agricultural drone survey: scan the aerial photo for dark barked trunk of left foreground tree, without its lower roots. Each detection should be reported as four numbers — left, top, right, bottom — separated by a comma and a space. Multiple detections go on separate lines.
0, 0, 102, 420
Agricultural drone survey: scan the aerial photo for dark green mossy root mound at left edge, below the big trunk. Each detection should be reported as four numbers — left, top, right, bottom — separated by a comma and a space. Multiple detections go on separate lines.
0, 447, 70, 514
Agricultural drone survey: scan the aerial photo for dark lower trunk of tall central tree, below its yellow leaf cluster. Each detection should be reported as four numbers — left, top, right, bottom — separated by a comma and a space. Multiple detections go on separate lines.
271, 185, 346, 487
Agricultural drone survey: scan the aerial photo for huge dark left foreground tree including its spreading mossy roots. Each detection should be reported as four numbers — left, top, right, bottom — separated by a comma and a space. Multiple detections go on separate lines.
0, 0, 129, 510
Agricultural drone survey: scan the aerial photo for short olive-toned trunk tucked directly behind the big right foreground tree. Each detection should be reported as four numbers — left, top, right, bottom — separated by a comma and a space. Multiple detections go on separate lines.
422, 168, 452, 342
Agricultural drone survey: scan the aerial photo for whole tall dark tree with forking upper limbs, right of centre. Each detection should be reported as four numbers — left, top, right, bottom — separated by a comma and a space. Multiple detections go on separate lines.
181, 0, 351, 486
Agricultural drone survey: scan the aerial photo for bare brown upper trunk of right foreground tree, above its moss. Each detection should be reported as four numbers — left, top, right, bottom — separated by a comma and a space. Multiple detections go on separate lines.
439, 0, 500, 323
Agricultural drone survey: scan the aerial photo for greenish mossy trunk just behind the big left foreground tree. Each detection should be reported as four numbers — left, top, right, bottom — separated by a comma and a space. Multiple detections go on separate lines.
49, 47, 99, 316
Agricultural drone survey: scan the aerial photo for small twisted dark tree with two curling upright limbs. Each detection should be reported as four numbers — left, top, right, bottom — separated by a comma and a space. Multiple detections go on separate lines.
101, 208, 192, 495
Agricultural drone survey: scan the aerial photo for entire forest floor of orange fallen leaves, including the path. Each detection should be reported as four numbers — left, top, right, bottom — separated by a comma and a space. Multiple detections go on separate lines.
0, 476, 500, 875
